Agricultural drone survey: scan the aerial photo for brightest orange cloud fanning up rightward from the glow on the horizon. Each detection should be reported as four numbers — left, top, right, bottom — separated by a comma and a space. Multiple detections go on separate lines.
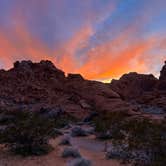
78, 33, 163, 79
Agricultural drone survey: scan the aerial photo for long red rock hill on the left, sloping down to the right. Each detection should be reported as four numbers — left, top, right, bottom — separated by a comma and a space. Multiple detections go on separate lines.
0, 61, 136, 118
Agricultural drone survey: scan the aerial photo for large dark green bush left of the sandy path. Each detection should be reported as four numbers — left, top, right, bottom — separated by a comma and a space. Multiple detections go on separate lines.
0, 111, 54, 155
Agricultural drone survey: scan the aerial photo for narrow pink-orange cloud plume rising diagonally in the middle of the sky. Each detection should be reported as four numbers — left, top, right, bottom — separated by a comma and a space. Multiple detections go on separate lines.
55, 25, 93, 72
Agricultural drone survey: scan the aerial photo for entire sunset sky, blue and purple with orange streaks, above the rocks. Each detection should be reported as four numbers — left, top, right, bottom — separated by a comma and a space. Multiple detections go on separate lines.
0, 0, 166, 81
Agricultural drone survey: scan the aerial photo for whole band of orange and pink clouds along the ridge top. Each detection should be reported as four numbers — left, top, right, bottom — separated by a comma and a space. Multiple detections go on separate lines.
0, 23, 165, 80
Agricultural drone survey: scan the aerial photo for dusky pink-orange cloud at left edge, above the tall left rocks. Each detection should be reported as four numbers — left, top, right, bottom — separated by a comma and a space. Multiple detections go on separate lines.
0, 26, 56, 68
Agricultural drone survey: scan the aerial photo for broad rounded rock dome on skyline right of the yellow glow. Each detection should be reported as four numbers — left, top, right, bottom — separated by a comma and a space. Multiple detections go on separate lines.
110, 72, 158, 99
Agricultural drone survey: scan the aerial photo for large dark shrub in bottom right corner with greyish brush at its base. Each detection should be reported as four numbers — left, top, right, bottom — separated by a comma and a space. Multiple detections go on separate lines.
107, 118, 166, 166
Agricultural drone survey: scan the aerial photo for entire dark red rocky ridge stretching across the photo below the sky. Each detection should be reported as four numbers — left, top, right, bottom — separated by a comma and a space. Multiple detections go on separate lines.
0, 60, 166, 120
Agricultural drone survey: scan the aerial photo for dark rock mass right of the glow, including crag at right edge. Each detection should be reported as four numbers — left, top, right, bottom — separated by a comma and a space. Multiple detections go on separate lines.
110, 63, 166, 111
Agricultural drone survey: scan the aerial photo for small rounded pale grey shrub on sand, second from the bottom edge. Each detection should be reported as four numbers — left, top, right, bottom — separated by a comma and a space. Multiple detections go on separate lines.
62, 147, 81, 158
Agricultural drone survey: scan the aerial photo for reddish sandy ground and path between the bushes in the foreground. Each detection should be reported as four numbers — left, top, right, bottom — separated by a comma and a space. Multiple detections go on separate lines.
0, 124, 130, 166
